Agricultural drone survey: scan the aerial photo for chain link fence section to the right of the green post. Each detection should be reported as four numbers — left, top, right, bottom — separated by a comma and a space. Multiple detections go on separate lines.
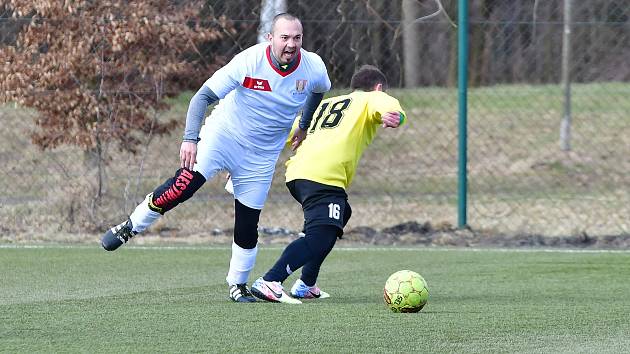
468, 0, 630, 235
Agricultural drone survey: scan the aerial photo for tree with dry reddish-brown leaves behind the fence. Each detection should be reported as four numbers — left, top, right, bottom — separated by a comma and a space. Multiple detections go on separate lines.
0, 0, 232, 198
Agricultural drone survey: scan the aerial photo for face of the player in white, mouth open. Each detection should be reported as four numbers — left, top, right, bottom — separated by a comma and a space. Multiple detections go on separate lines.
269, 18, 302, 64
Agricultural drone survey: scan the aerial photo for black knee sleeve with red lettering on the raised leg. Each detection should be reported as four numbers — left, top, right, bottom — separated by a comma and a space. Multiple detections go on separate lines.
149, 168, 206, 214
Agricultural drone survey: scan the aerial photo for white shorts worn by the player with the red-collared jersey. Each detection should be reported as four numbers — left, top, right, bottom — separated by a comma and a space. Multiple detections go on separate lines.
193, 124, 280, 209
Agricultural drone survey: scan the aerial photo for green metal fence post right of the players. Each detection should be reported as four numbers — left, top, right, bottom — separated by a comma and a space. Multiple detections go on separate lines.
457, 0, 468, 228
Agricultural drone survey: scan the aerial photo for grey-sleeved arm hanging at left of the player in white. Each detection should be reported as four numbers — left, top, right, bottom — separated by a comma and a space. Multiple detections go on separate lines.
179, 85, 219, 170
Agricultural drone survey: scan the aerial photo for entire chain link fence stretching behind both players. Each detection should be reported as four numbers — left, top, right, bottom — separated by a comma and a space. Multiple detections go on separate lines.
0, 0, 630, 239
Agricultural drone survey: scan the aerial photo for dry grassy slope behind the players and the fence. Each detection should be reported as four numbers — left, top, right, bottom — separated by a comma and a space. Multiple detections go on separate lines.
0, 83, 630, 240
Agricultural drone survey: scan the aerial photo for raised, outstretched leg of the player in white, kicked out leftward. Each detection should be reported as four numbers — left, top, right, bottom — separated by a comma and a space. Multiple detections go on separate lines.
101, 126, 229, 251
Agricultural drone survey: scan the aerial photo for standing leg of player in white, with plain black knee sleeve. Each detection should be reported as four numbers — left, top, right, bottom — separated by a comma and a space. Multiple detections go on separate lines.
226, 149, 278, 302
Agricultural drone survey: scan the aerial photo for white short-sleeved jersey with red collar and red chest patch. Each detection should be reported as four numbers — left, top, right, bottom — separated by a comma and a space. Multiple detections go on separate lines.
205, 43, 330, 152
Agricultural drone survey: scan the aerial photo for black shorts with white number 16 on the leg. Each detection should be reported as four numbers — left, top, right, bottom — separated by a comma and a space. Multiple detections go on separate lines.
287, 179, 352, 237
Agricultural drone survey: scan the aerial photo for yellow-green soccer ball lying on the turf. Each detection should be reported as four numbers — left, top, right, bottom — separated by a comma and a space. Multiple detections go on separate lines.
383, 270, 429, 312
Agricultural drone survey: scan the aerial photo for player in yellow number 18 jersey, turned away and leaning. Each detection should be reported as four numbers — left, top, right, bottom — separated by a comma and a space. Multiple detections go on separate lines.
251, 65, 405, 303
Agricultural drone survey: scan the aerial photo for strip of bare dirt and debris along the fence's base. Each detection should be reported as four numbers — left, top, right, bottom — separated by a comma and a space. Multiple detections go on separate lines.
0, 221, 630, 249
